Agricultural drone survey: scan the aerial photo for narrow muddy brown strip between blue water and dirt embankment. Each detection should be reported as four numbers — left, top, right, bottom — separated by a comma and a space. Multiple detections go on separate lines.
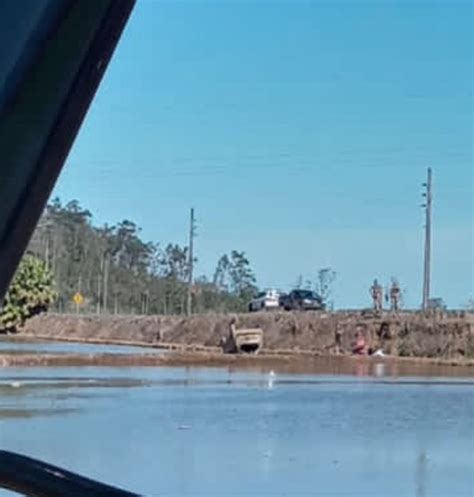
0, 344, 474, 377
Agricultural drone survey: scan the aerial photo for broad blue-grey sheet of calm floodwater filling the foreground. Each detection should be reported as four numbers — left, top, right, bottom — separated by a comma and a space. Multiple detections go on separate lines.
0, 365, 474, 497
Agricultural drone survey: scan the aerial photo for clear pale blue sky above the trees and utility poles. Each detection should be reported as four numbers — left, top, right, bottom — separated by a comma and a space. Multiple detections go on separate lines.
54, 0, 474, 307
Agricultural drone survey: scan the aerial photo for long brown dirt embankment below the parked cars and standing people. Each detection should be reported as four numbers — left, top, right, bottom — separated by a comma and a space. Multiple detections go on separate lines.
21, 311, 474, 361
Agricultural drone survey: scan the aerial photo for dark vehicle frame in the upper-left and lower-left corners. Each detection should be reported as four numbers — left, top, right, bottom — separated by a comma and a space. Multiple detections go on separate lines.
0, 0, 139, 497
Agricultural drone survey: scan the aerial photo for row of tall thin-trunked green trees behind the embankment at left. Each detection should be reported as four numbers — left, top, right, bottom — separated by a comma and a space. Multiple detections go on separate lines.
28, 198, 257, 314
